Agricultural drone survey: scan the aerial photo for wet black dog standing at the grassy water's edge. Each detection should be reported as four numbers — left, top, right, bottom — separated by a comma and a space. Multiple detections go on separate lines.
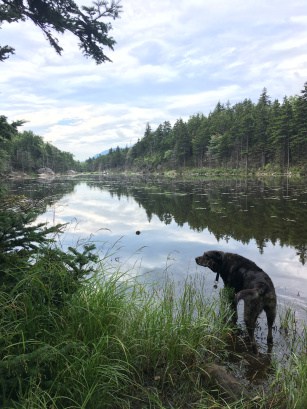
195, 251, 276, 354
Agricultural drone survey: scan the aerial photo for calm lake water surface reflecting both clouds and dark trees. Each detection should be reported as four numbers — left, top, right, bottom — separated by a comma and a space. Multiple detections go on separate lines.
6, 176, 307, 319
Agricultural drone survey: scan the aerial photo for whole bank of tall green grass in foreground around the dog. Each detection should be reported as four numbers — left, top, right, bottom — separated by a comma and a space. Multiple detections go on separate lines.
0, 256, 307, 409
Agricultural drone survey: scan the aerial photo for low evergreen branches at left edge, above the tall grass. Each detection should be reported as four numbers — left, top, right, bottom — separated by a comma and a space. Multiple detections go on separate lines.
0, 190, 96, 292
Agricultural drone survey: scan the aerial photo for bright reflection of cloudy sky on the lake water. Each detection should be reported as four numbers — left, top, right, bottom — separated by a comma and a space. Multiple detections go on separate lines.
35, 183, 307, 302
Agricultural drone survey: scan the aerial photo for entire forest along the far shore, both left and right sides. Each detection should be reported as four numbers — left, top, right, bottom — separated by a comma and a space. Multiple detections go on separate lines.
0, 82, 307, 174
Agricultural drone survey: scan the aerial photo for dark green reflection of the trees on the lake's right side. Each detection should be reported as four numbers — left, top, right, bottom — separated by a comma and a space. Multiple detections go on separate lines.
88, 178, 307, 264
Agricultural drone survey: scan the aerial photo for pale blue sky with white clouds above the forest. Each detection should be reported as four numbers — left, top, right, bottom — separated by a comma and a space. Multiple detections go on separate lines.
0, 0, 307, 161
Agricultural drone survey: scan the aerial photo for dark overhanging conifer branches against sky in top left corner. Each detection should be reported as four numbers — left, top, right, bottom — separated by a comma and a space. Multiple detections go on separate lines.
0, 0, 122, 64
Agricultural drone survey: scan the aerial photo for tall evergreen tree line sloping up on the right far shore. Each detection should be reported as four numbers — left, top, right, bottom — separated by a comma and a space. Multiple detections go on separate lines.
86, 82, 307, 171
